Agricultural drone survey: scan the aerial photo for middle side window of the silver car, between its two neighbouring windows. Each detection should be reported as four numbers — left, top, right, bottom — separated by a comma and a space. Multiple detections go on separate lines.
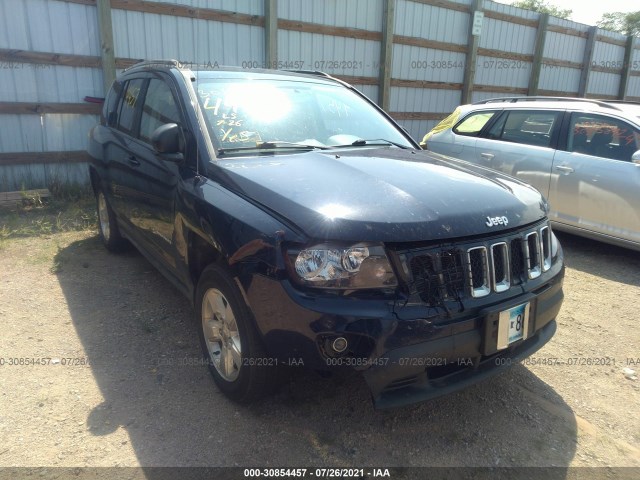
487, 110, 560, 147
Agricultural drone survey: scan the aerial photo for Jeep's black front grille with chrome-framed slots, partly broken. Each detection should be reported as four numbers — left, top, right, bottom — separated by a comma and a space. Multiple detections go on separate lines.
400, 224, 551, 306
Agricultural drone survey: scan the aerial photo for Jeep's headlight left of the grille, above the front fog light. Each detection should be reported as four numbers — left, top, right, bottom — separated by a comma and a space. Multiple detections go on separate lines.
288, 244, 398, 290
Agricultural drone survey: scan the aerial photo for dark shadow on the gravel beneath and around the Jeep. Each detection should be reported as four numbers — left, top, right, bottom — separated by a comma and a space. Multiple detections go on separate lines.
56, 233, 577, 478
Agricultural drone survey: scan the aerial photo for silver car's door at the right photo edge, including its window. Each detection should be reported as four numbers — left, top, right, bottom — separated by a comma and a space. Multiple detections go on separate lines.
549, 112, 640, 242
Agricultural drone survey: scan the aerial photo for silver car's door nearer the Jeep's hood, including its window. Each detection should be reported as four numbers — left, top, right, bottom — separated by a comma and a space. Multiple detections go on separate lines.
475, 109, 562, 196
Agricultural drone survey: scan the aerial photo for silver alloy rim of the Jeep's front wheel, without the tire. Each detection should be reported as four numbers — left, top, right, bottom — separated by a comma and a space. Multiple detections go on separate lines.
202, 288, 242, 382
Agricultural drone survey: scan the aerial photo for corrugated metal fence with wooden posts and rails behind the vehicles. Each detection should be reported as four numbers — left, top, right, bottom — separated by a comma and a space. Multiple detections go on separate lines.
0, 0, 640, 191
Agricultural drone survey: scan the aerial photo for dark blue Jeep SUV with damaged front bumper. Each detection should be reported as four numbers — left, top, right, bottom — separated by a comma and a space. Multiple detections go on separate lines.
89, 61, 564, 408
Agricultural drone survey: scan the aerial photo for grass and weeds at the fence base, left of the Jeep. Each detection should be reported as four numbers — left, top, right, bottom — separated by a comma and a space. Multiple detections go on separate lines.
0, 195, 98, 248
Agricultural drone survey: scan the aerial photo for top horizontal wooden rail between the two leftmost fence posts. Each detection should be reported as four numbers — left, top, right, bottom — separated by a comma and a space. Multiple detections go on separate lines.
111, 0, 264, 27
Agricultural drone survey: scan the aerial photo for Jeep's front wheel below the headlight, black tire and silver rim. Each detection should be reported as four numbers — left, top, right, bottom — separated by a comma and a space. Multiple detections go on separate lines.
195, 264, 279, 403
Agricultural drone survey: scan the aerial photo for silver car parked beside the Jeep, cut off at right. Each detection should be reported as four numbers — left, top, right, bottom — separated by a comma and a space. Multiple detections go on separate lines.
421, 97, 640, 250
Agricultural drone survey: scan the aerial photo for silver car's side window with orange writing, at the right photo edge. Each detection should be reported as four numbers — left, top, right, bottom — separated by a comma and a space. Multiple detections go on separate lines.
567, 113, 640, 162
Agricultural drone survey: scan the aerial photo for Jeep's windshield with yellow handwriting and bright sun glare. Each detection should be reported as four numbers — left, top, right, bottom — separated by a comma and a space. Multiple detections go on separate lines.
197, 79, 413, 154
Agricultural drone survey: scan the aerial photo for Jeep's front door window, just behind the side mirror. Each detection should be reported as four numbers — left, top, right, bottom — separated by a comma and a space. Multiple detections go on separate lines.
140, 78, 181, 143
